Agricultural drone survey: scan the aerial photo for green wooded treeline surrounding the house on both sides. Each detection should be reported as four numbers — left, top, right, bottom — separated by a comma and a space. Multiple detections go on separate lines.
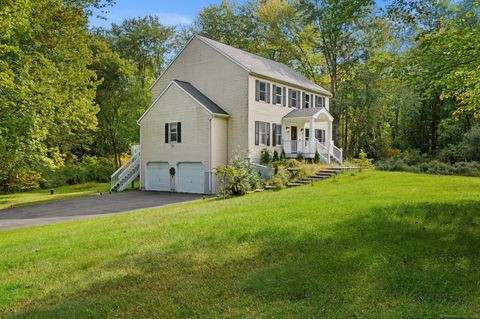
0, 0, 480, 192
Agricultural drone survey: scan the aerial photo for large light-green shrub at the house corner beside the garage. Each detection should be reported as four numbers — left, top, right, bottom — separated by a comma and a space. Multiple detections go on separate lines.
215, 154, 260, 197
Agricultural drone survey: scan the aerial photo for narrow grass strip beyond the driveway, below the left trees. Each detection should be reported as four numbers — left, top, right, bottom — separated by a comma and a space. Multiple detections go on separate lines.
0, 183, 110, 214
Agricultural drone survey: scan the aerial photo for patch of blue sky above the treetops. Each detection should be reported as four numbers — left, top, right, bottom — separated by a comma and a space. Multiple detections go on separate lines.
90, 0, 248, 27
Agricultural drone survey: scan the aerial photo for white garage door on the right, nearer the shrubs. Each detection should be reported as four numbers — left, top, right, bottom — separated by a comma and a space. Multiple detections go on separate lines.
177, 163, 205, 194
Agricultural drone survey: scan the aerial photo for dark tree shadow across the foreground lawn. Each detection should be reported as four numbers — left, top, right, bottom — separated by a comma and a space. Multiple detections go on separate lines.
7, 201, 480, 318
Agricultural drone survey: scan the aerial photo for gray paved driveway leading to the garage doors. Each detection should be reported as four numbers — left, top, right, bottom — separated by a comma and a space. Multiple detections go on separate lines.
0, 191, 203, 230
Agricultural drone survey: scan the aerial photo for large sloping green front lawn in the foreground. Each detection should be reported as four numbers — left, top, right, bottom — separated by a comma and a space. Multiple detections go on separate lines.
0, 171, 480, 318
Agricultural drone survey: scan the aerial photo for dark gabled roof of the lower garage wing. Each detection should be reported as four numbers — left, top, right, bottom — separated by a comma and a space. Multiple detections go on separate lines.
137, 80, 229, 124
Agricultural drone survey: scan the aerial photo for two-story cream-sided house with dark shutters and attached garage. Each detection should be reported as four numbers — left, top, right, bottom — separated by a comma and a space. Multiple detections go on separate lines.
109, 35, 342, 193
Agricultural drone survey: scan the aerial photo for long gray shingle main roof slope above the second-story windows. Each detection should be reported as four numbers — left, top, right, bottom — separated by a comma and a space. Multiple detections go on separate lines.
195, 35, 331, 95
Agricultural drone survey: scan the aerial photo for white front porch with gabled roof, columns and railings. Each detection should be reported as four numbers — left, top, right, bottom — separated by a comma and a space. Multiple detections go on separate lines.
282, 108, 343, 164
